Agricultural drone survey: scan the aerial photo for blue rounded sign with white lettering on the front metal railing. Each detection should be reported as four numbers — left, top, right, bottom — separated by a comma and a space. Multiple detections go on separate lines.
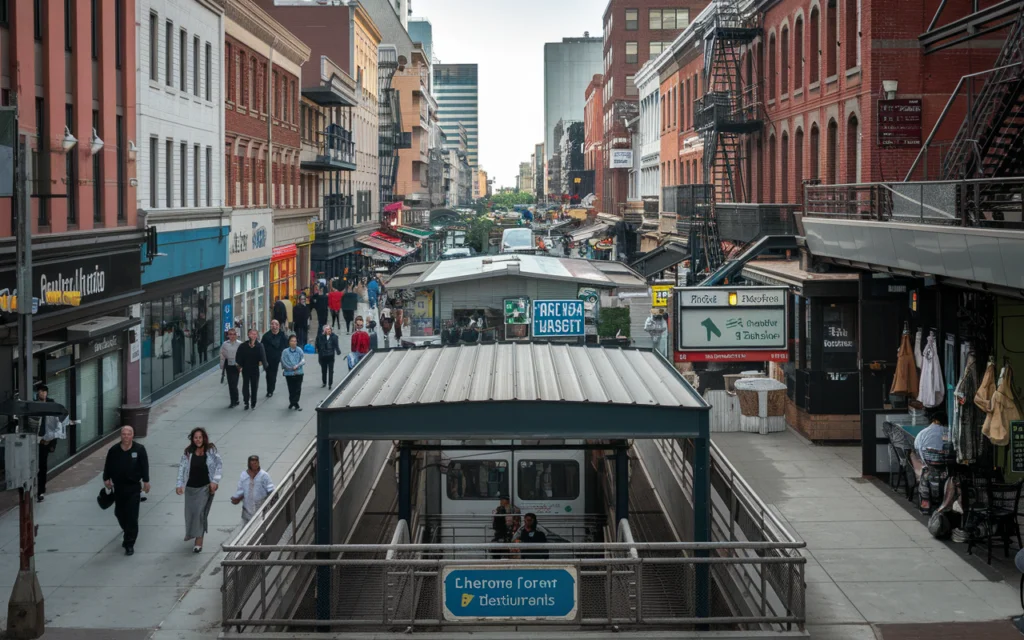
441, 565, 580, 622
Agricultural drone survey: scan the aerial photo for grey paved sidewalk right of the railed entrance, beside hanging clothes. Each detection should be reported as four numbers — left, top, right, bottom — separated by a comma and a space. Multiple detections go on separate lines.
712, 430, 1021, 640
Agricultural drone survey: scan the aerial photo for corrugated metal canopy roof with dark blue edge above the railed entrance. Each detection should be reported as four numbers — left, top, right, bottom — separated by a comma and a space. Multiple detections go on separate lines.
316, 342, 710, 440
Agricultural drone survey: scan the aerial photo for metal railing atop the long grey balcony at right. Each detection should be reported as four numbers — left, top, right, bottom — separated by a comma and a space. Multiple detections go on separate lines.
804, 178, 1024, 229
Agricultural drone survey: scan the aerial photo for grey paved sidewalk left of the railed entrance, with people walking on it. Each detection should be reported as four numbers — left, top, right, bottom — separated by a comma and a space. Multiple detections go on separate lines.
0, 307, 383, 640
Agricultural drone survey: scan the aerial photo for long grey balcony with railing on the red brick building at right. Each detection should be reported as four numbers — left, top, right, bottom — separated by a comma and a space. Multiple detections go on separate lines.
803, 178, 1024, 290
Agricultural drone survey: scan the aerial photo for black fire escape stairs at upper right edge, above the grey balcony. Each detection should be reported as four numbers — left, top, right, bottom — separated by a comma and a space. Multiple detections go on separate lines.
942, 11, 1024, 221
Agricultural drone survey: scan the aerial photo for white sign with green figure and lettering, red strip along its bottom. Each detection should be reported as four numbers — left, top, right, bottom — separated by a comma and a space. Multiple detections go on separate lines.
675, 287, 788, 362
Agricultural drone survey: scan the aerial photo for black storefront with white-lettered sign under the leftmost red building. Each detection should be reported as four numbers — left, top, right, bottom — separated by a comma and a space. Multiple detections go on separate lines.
0, 229, 142, 471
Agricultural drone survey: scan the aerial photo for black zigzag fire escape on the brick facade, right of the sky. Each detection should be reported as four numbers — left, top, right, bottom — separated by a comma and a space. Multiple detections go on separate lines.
689, 0, 763, 279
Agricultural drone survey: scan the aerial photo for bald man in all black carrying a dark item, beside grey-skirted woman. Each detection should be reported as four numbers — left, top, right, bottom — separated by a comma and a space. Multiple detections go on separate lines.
103, 425, 150, 556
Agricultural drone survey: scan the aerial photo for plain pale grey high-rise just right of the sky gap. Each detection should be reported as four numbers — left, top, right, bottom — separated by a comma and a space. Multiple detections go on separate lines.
544, 37, 602, 166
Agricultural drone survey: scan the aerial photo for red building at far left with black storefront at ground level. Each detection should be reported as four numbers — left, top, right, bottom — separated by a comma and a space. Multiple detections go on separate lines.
0, 0, 144, 474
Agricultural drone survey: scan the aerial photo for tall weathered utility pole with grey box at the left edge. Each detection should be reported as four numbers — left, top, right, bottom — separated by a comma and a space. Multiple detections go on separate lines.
7, 104, 48, 638
